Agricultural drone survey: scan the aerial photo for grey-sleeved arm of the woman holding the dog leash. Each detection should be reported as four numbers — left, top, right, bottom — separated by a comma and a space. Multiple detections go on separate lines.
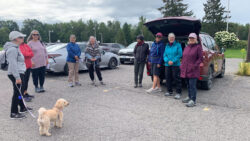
6, 48, 21, 80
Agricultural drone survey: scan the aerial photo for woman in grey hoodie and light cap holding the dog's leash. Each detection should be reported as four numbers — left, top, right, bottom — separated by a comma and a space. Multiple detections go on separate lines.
4, 31, 31, 119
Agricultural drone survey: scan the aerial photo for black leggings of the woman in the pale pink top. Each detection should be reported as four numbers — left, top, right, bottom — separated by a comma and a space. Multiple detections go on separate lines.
32, 66, 46, 88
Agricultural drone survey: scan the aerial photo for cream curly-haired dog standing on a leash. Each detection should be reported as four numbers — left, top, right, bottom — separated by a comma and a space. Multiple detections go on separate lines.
37, 98, 69, 136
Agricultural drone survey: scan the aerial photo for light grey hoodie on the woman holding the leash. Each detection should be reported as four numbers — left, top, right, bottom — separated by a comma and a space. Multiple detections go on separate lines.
4, 42, 26, 80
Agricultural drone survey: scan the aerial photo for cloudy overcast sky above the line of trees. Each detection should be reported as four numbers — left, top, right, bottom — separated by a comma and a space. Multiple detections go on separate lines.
0, 0, 250, 24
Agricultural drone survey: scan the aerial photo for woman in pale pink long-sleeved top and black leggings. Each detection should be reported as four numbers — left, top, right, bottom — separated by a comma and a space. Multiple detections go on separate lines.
27, 30, 48, 93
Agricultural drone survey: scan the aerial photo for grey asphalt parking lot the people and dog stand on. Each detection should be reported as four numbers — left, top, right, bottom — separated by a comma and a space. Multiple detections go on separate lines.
0, 59, 250, 141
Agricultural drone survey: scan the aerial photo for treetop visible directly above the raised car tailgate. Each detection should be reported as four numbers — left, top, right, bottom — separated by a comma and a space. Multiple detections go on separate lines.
158, 0, 193, 17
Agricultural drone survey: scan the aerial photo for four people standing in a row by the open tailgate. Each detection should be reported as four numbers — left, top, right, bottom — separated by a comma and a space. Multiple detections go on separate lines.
134, 33, 203, 107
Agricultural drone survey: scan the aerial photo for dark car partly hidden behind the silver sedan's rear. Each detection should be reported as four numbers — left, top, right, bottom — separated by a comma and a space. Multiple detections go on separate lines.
100, 43, 125, 54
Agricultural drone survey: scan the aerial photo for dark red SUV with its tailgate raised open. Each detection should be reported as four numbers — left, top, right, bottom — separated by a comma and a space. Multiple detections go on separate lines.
145, 17, 225, 90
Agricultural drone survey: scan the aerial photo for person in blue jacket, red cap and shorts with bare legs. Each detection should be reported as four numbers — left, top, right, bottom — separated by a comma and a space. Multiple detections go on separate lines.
147, 33, 165, 93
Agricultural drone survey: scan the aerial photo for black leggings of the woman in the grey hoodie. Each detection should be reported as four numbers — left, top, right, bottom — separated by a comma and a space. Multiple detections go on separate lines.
8, 74, 25, 113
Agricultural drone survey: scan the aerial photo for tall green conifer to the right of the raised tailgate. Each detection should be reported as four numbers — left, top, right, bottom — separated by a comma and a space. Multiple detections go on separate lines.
202, 0, 226, 36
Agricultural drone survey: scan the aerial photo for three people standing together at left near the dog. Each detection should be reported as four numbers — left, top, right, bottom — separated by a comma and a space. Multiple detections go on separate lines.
4, 30, 48, 119
